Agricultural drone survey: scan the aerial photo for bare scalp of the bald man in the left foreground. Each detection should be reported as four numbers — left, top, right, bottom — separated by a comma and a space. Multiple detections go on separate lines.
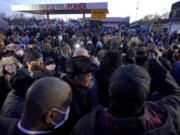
25, 77, 71, 114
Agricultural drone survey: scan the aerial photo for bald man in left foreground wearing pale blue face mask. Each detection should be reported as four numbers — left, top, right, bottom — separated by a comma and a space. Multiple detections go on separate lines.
0, 77, 72, 135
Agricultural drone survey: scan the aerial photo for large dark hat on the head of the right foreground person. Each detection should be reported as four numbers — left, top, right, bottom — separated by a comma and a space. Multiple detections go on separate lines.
109, 64, 150, 114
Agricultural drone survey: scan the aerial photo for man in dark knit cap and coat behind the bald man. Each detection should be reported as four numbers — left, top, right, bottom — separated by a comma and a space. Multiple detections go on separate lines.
0, 48, 53, 118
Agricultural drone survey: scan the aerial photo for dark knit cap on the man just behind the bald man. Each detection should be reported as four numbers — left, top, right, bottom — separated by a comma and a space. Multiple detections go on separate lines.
24, 48, 43, 62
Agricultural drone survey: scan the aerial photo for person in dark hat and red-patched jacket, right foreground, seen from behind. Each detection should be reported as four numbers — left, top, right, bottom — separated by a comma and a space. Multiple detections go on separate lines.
72, 63, 180, 135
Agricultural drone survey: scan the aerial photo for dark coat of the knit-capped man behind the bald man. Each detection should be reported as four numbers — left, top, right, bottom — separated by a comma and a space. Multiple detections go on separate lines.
0, 68, 52, 118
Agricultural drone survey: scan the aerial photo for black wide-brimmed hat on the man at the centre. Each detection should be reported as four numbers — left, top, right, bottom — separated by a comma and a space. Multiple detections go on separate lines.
65, 56, 98, 75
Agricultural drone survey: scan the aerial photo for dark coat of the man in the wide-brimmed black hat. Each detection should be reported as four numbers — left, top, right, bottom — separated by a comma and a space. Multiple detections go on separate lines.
63, 77, 93, 134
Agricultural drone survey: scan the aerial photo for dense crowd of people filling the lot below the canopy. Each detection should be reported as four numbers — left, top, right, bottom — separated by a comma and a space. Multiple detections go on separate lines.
0, 20, 180, 135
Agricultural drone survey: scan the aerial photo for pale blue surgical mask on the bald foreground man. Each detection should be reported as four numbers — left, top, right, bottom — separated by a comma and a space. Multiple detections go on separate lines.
51, 106, 70, 129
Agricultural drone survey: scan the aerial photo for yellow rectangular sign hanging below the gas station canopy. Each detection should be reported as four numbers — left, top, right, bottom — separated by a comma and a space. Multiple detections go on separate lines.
91, 10, 106, 19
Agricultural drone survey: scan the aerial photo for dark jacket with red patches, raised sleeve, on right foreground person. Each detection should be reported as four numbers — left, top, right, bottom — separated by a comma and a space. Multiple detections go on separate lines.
72, 60, 180, 135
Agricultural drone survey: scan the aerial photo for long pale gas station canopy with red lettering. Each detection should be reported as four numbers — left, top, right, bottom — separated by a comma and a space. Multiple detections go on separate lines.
11, 2, 108, 14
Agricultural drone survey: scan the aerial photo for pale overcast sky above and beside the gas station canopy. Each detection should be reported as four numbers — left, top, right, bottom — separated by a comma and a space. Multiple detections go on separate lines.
0, 0, 178, 21
